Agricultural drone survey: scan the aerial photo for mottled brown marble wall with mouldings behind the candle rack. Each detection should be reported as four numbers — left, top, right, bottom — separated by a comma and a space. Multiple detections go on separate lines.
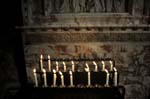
22, 0, 150, 99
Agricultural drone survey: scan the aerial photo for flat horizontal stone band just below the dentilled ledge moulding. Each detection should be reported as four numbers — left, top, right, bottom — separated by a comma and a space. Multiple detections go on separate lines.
25, 32, 150, 44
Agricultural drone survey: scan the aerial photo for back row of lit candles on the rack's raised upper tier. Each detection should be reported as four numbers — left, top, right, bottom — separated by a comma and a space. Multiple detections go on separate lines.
40, 55, 113, 72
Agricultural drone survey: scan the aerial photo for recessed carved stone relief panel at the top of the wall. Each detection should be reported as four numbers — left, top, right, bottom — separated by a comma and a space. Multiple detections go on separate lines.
45, 0, 125, 14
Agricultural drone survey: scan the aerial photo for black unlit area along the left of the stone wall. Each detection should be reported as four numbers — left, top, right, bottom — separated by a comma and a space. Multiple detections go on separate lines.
0, 0, 23, 99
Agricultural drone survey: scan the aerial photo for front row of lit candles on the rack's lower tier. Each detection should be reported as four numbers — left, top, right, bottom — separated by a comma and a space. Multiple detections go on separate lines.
33, 63, 117, 87
